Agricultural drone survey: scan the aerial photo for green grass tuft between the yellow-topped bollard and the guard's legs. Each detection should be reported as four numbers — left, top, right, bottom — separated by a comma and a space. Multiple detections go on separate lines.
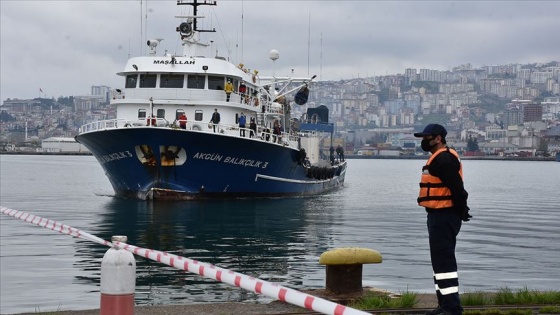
348, 292, 418, 309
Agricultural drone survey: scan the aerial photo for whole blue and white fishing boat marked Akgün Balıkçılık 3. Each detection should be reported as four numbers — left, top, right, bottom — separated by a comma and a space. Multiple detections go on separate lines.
76, 0, 347, 200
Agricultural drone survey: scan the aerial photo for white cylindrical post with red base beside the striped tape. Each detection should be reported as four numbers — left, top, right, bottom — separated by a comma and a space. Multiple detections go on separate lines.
100, 236, 136, 315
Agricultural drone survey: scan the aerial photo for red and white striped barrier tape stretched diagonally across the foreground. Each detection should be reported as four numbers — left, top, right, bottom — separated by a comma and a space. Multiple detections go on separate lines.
0, 206, 370, 315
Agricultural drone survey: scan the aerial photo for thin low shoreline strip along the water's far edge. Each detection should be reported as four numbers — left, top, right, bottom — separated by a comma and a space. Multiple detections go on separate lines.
0, 151, 556, 162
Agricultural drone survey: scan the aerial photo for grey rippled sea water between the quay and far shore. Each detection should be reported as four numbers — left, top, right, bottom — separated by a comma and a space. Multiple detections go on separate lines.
0, 155, 560, 314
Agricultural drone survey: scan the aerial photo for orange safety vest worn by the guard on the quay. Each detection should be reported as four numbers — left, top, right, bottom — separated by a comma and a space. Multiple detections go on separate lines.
418, 147, 463, 209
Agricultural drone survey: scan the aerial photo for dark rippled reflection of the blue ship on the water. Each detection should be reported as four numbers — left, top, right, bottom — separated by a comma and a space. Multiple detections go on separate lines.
70, 197, 337, 304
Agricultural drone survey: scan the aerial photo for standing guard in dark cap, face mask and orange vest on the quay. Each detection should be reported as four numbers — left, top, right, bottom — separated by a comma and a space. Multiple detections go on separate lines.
414, 124, 472, 315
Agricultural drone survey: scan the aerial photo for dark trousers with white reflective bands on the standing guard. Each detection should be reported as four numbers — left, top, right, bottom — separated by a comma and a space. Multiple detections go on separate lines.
427, 210, 463, 314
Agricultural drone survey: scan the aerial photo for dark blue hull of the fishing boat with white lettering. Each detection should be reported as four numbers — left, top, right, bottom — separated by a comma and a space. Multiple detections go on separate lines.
76, 127, 346, 200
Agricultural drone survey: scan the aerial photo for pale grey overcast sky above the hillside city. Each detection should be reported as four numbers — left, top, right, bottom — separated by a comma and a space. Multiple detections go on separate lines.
0, 0, 560, 101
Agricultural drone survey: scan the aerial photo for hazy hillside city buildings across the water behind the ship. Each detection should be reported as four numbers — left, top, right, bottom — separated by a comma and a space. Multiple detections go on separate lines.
0, 61, 560, 156
